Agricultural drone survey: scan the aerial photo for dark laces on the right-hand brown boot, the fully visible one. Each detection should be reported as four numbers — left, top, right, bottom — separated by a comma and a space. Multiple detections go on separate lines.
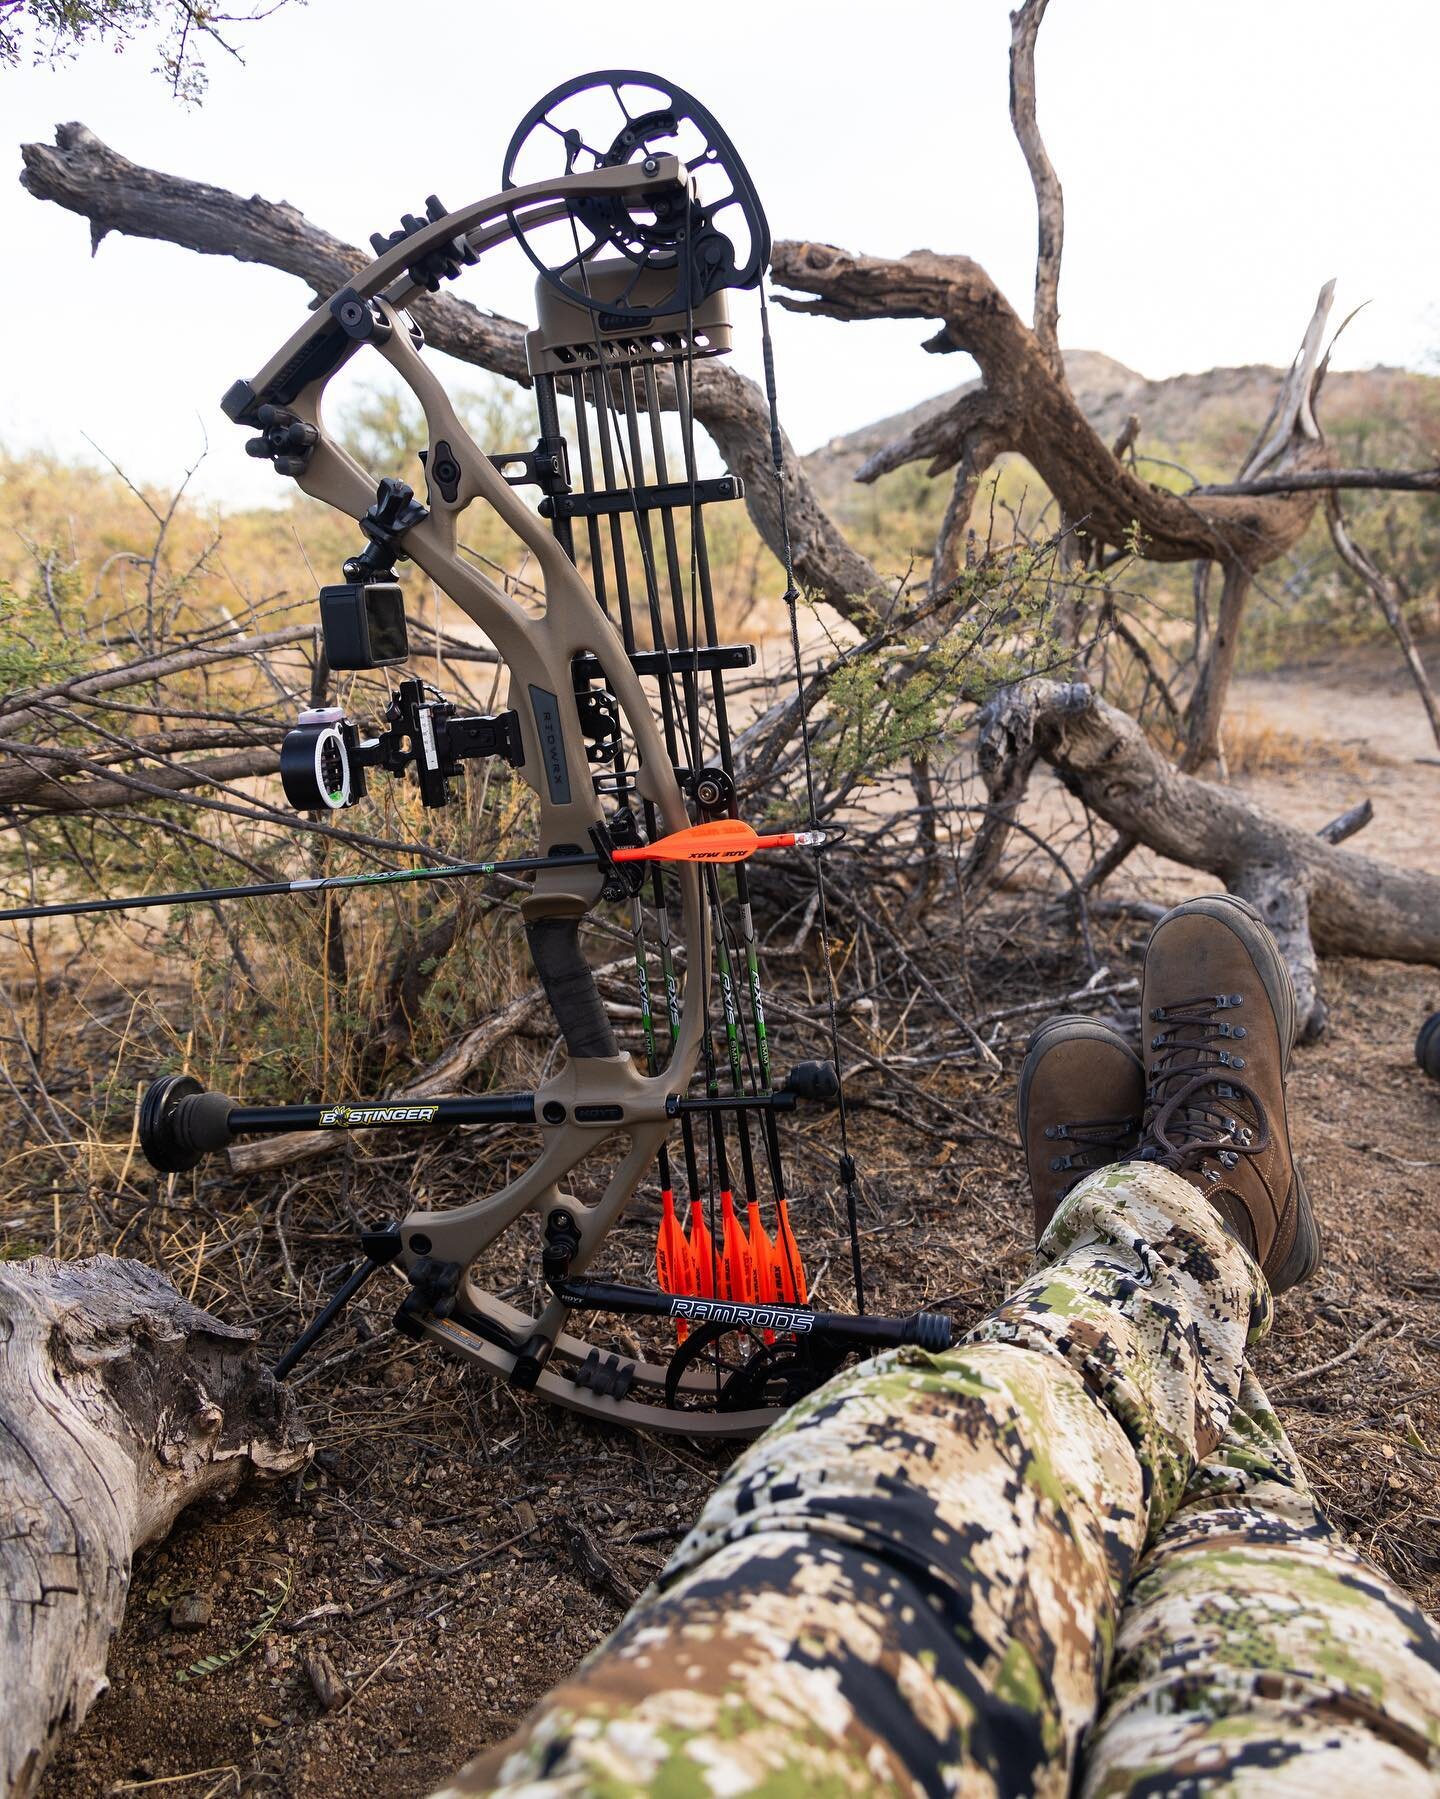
1138, 993, 1271, 1180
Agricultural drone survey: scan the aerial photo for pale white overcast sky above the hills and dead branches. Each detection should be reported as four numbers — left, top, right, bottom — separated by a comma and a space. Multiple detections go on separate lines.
0, 0, 1440, 506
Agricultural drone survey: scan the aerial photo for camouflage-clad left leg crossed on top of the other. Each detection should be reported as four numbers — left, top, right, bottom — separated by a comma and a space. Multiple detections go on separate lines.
439, 1164, 1264, 1799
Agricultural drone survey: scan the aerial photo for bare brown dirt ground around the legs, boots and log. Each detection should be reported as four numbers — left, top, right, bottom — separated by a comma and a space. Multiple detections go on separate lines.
33, 657, 1440, 1799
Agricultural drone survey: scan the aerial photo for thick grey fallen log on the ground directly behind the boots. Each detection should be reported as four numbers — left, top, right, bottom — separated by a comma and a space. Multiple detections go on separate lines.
981, 680, 1440, 1038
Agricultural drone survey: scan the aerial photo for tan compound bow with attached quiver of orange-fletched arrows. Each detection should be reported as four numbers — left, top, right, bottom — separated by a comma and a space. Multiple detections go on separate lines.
16, 70, 949, 1436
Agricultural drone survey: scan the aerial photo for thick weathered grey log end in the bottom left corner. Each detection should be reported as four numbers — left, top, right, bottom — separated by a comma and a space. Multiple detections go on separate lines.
0, 1256, 308, 1795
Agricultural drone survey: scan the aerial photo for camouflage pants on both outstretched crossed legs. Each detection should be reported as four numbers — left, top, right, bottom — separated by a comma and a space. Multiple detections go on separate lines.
439, 1162, 1440, 1799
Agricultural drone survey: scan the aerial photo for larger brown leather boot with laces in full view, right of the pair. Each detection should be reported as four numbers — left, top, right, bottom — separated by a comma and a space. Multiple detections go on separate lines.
1139, 894, 1319, 1293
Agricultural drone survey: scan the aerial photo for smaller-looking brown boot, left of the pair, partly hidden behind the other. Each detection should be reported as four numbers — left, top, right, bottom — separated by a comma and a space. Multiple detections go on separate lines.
1015, 1016, 1145, 1243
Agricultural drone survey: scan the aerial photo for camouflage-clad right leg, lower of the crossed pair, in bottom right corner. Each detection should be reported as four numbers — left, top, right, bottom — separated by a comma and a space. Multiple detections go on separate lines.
1084, 1371, 1440, 1799
